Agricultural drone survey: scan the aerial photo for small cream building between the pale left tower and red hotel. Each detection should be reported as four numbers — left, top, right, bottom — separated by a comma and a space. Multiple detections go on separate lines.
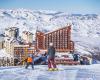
22, 31, 33, 43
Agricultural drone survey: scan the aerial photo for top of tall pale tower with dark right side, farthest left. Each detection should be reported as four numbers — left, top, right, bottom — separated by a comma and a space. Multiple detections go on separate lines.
5, 27, 19, 38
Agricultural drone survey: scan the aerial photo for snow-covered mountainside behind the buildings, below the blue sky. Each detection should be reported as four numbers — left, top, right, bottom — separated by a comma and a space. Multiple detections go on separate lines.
0, 9, 100, 59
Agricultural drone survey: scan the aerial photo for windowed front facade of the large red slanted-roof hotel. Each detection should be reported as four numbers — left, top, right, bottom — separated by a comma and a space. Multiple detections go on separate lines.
37, 27, 74, 49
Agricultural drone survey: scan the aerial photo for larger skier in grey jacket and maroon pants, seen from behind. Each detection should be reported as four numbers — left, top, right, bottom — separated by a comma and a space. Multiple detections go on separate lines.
48, 43, 58, 71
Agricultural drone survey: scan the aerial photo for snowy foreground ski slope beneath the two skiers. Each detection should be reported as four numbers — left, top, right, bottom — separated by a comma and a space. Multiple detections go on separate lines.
0, 64, 100, 80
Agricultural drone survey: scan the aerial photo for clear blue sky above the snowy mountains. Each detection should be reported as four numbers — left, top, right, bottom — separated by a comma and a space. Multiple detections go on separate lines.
0, 0, 100, 14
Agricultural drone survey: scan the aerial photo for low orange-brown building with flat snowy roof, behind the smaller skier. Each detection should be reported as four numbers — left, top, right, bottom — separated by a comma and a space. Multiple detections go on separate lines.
14, 45, 35, 60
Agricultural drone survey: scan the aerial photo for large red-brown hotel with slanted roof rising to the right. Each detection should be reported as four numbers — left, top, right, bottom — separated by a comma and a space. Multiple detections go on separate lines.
36, 25, 74, 52
